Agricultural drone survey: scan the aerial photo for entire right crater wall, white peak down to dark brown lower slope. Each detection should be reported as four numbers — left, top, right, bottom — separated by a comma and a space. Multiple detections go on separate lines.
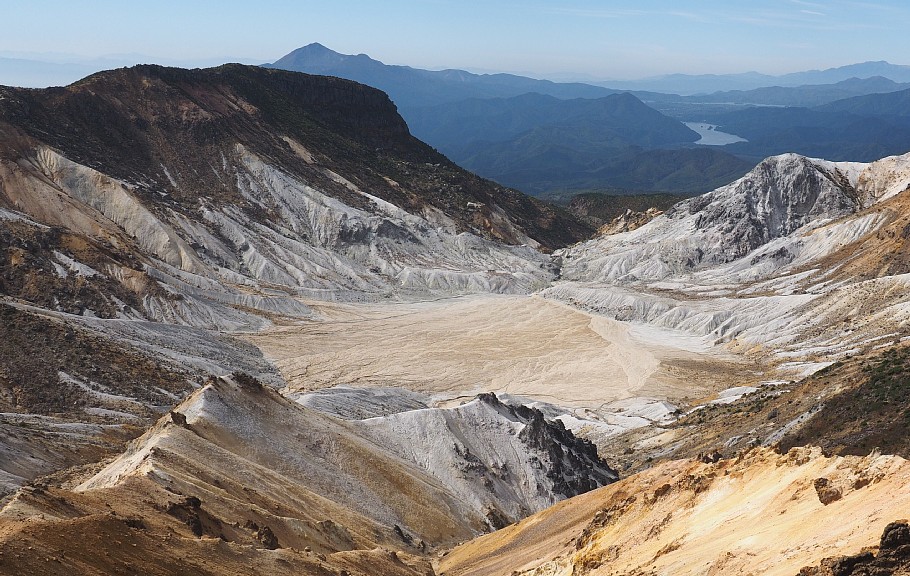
541, 148, 910, 473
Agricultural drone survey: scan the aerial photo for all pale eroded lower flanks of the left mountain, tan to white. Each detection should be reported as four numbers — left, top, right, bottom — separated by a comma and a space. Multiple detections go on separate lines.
10, 144, 552, 330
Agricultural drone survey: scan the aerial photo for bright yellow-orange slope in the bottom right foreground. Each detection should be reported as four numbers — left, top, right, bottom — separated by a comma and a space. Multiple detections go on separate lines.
440, 449, 910, 576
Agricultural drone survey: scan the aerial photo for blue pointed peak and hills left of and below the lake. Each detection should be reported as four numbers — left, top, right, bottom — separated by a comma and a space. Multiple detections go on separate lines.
269, 44, 764, 194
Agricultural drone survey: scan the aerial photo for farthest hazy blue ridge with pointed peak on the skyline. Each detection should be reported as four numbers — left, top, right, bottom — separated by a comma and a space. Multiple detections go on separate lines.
266, 43, 616, 109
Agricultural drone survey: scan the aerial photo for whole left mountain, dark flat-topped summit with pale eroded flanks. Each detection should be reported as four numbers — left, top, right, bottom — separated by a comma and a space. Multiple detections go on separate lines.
0, 65, 588, 327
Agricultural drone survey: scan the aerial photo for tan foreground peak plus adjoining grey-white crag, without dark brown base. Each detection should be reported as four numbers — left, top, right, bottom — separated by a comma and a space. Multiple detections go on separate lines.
78, 375, 616, 551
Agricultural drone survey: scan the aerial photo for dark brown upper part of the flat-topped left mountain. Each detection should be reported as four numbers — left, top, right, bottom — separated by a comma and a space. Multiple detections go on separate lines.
0, 65, 592, 258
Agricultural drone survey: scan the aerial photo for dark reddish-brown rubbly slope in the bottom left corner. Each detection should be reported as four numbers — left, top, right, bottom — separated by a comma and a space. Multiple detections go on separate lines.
0, 478, 432, 576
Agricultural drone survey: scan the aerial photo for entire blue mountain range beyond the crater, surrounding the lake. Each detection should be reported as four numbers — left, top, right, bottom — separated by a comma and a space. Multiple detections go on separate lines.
268, 44, 910, 197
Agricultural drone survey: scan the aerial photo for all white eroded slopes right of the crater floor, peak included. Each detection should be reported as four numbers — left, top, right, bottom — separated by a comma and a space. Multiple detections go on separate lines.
542, 154, 910, 368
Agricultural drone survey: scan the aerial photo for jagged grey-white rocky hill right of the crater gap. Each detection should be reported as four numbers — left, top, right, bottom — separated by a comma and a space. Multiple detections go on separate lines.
562, 154, 859, 283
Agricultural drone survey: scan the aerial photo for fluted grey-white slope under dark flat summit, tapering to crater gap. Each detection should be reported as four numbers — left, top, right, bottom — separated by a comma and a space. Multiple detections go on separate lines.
215, 146, 547, 294
